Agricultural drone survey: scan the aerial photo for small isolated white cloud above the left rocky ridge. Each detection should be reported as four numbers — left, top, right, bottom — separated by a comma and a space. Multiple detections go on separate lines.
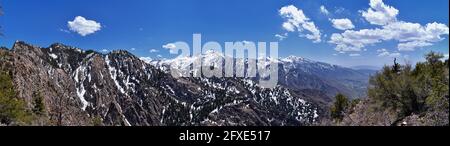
67, 16, 102, 36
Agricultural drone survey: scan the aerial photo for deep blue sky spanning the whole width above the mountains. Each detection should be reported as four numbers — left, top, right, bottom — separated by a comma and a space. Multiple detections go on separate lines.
0, 0, 449, 66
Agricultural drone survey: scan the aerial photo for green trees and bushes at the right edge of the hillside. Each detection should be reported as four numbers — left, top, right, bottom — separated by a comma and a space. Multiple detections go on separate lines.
368, 52, 449, 122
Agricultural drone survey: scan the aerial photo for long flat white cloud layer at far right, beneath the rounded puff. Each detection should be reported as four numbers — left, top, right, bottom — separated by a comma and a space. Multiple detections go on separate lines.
329, 21, 449, 51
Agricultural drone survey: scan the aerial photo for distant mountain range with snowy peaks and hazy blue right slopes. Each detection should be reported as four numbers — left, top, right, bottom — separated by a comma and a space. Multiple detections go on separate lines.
140, 51, 376, 99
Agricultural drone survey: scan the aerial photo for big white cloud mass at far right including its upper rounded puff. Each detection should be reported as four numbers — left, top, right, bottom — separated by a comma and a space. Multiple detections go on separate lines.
328, 0, 449, 52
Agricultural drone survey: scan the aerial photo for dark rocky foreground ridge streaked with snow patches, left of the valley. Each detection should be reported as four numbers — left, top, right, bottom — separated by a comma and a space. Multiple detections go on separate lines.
1, 41, 327, 126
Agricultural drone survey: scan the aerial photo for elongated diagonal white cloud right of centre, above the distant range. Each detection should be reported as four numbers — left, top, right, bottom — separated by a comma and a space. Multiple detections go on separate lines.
279, 5, 321, 43
